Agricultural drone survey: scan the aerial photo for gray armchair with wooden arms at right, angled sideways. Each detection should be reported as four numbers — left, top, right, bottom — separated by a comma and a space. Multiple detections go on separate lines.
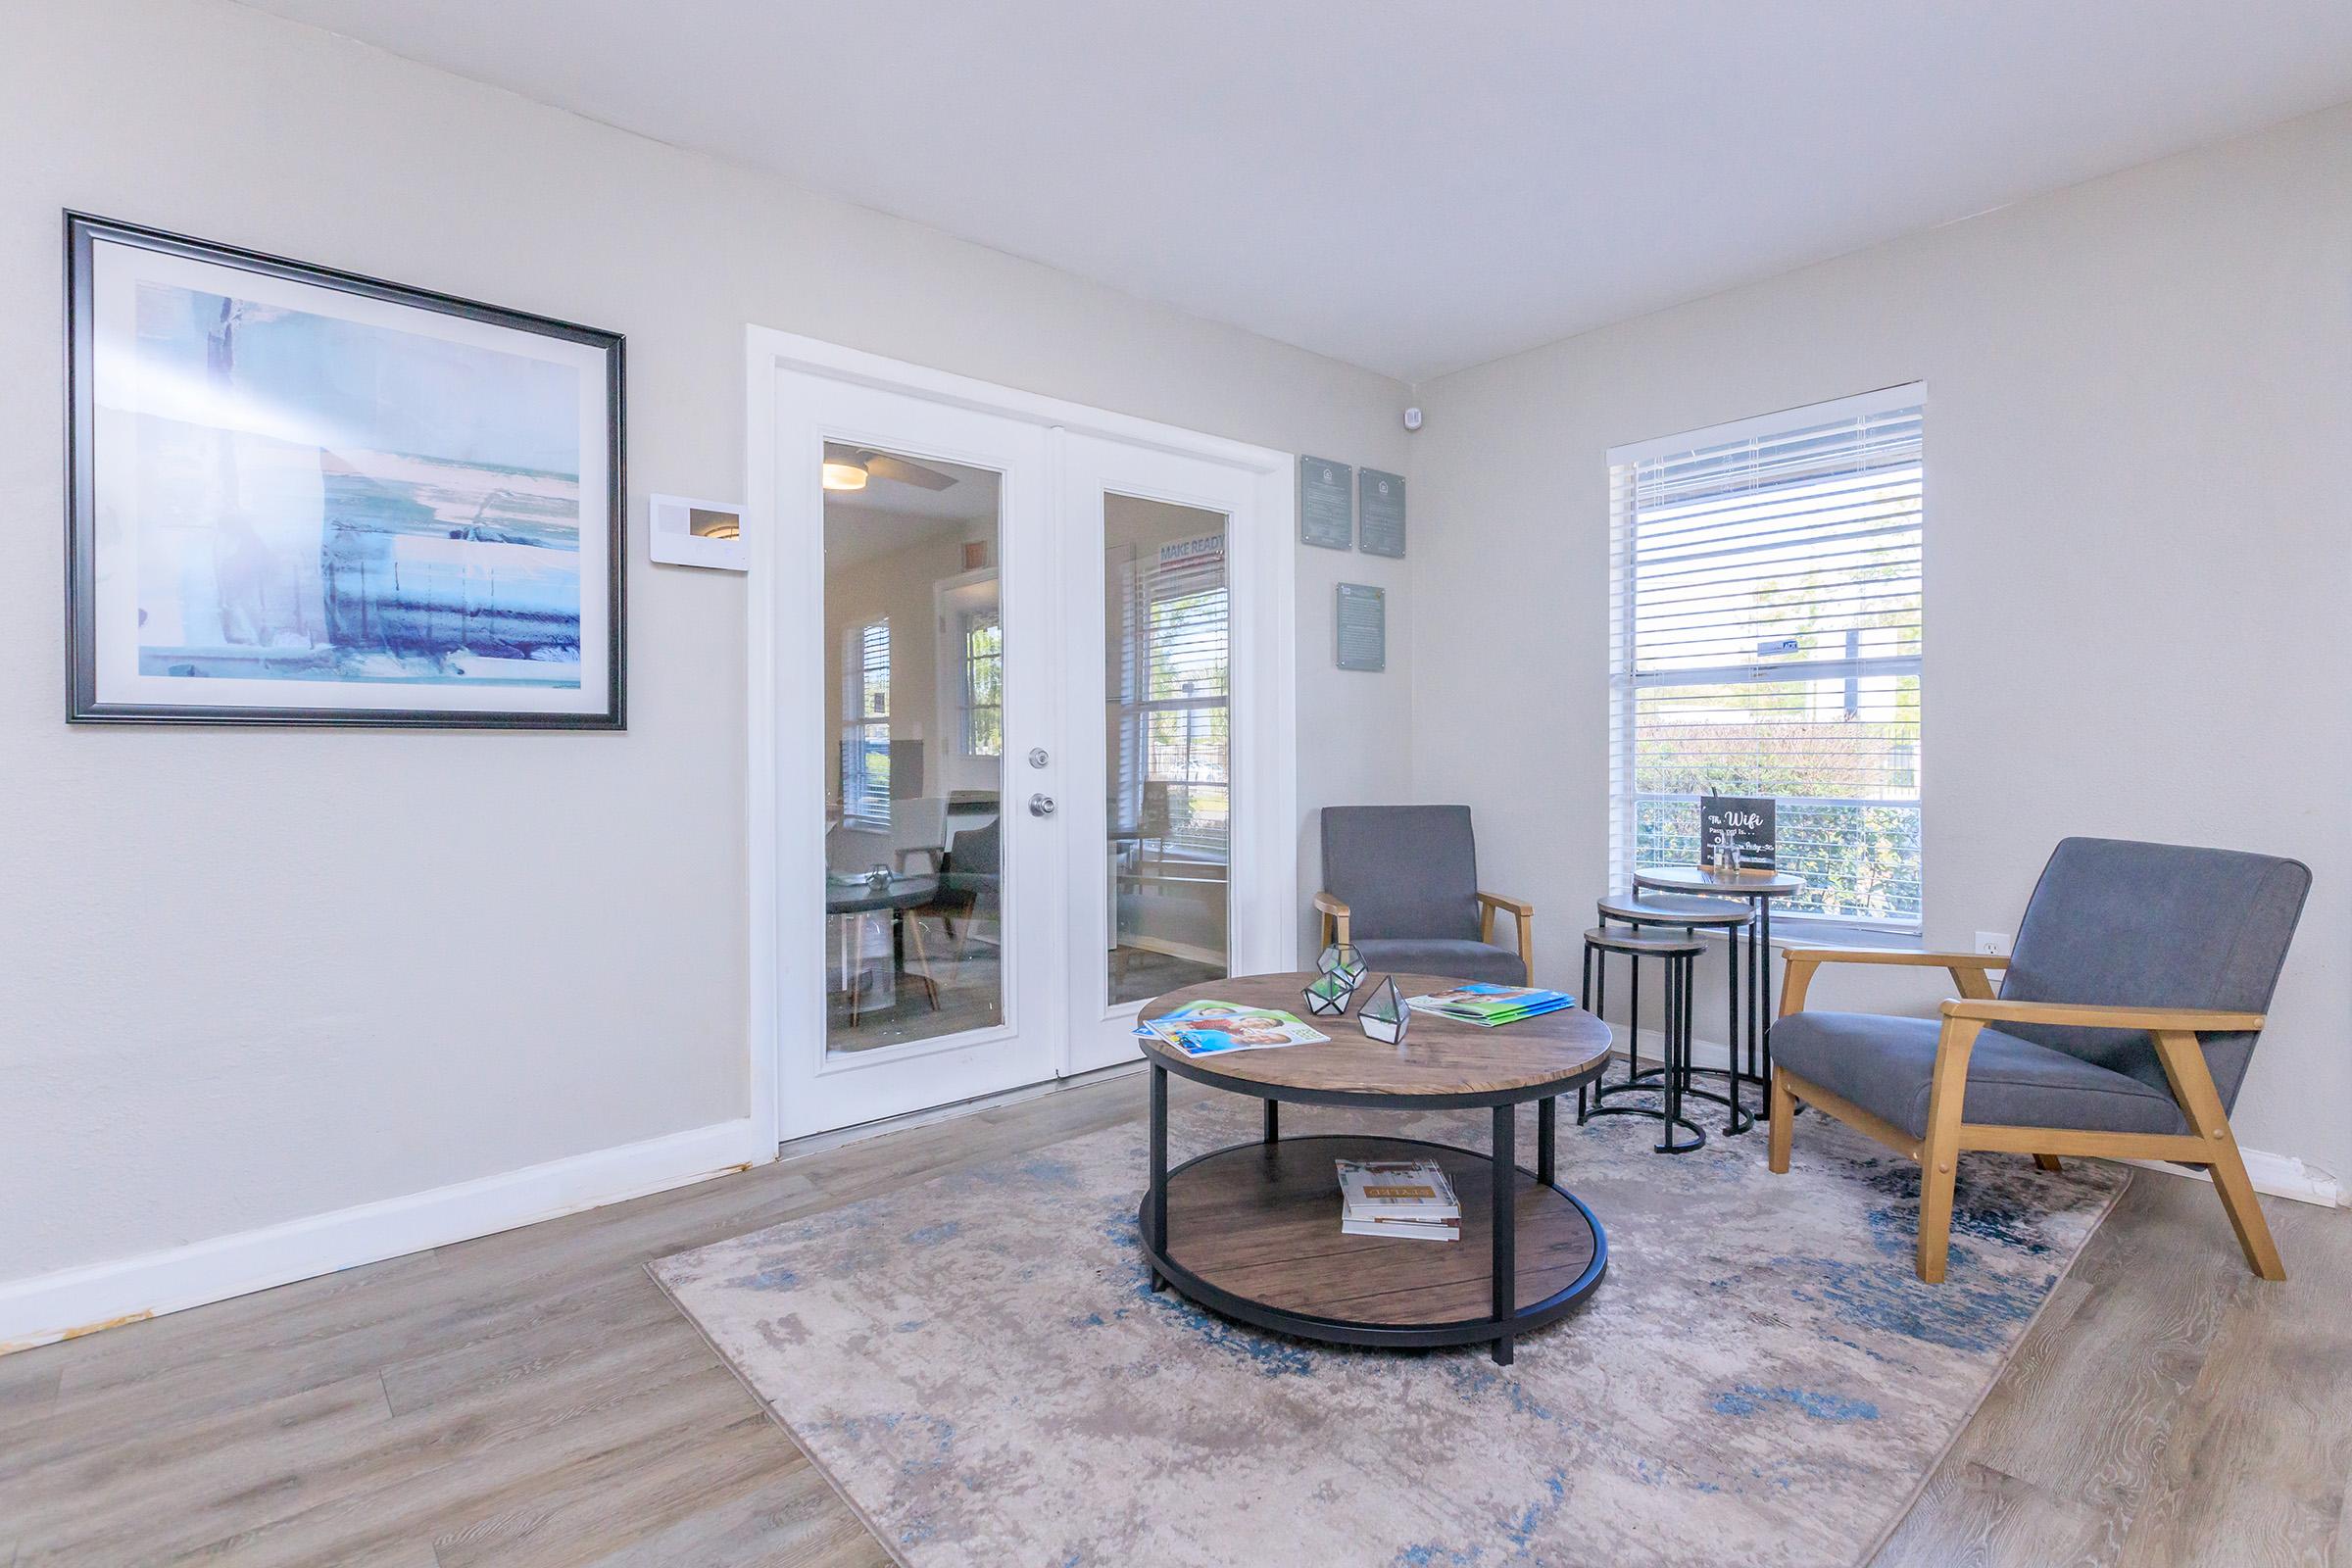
1771, 839, 2312, 1284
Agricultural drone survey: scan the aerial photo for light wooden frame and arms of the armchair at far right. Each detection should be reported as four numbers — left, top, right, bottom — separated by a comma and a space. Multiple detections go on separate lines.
1771, 948, 2286, 1284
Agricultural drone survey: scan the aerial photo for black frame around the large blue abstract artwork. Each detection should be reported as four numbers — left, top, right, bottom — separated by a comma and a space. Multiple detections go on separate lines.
64, 209, 628, 731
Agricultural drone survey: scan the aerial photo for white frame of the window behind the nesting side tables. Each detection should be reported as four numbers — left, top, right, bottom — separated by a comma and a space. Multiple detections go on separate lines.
1606, 381, 1929, 945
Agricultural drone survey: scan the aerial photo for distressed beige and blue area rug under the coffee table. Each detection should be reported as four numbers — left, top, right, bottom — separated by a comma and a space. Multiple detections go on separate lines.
652, 1084, 2127, 1568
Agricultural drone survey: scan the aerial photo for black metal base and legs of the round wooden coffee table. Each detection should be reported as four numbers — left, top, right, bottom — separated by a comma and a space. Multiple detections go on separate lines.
1136, 1062, 1609, 1366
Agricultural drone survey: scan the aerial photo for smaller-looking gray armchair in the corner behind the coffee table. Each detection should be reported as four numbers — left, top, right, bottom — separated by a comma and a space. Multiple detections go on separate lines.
1315, 807, 1536, 985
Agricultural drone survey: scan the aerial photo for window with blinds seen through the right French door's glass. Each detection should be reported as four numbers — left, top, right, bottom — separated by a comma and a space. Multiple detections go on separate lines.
1112, 534, 1233, 862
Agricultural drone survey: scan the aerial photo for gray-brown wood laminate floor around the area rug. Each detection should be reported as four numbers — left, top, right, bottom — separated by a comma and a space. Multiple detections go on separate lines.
0, 1077, 2352, 1568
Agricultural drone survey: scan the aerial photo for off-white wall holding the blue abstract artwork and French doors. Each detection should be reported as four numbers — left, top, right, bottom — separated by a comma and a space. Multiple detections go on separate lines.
0, 0, 1409, 1338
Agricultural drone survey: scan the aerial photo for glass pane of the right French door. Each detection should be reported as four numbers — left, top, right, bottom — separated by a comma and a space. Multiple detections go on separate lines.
1103, 494, 1233, 1006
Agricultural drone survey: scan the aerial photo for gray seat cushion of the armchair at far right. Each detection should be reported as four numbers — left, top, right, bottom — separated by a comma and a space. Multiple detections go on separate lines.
1771, 1013, 2189, 1138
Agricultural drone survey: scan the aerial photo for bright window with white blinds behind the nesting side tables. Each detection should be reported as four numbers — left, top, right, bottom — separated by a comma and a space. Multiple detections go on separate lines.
1609, 385, 1927, 931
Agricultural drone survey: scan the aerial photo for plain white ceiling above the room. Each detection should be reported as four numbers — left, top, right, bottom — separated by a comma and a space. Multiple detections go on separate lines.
247, 0, 2352, 378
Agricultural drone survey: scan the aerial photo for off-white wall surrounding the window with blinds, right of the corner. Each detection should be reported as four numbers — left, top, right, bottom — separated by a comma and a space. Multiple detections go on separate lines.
1413, 108, 2352, 1173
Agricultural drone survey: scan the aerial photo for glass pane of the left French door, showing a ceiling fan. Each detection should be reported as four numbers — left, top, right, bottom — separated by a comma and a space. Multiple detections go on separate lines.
823, 442, 1006, 1055
